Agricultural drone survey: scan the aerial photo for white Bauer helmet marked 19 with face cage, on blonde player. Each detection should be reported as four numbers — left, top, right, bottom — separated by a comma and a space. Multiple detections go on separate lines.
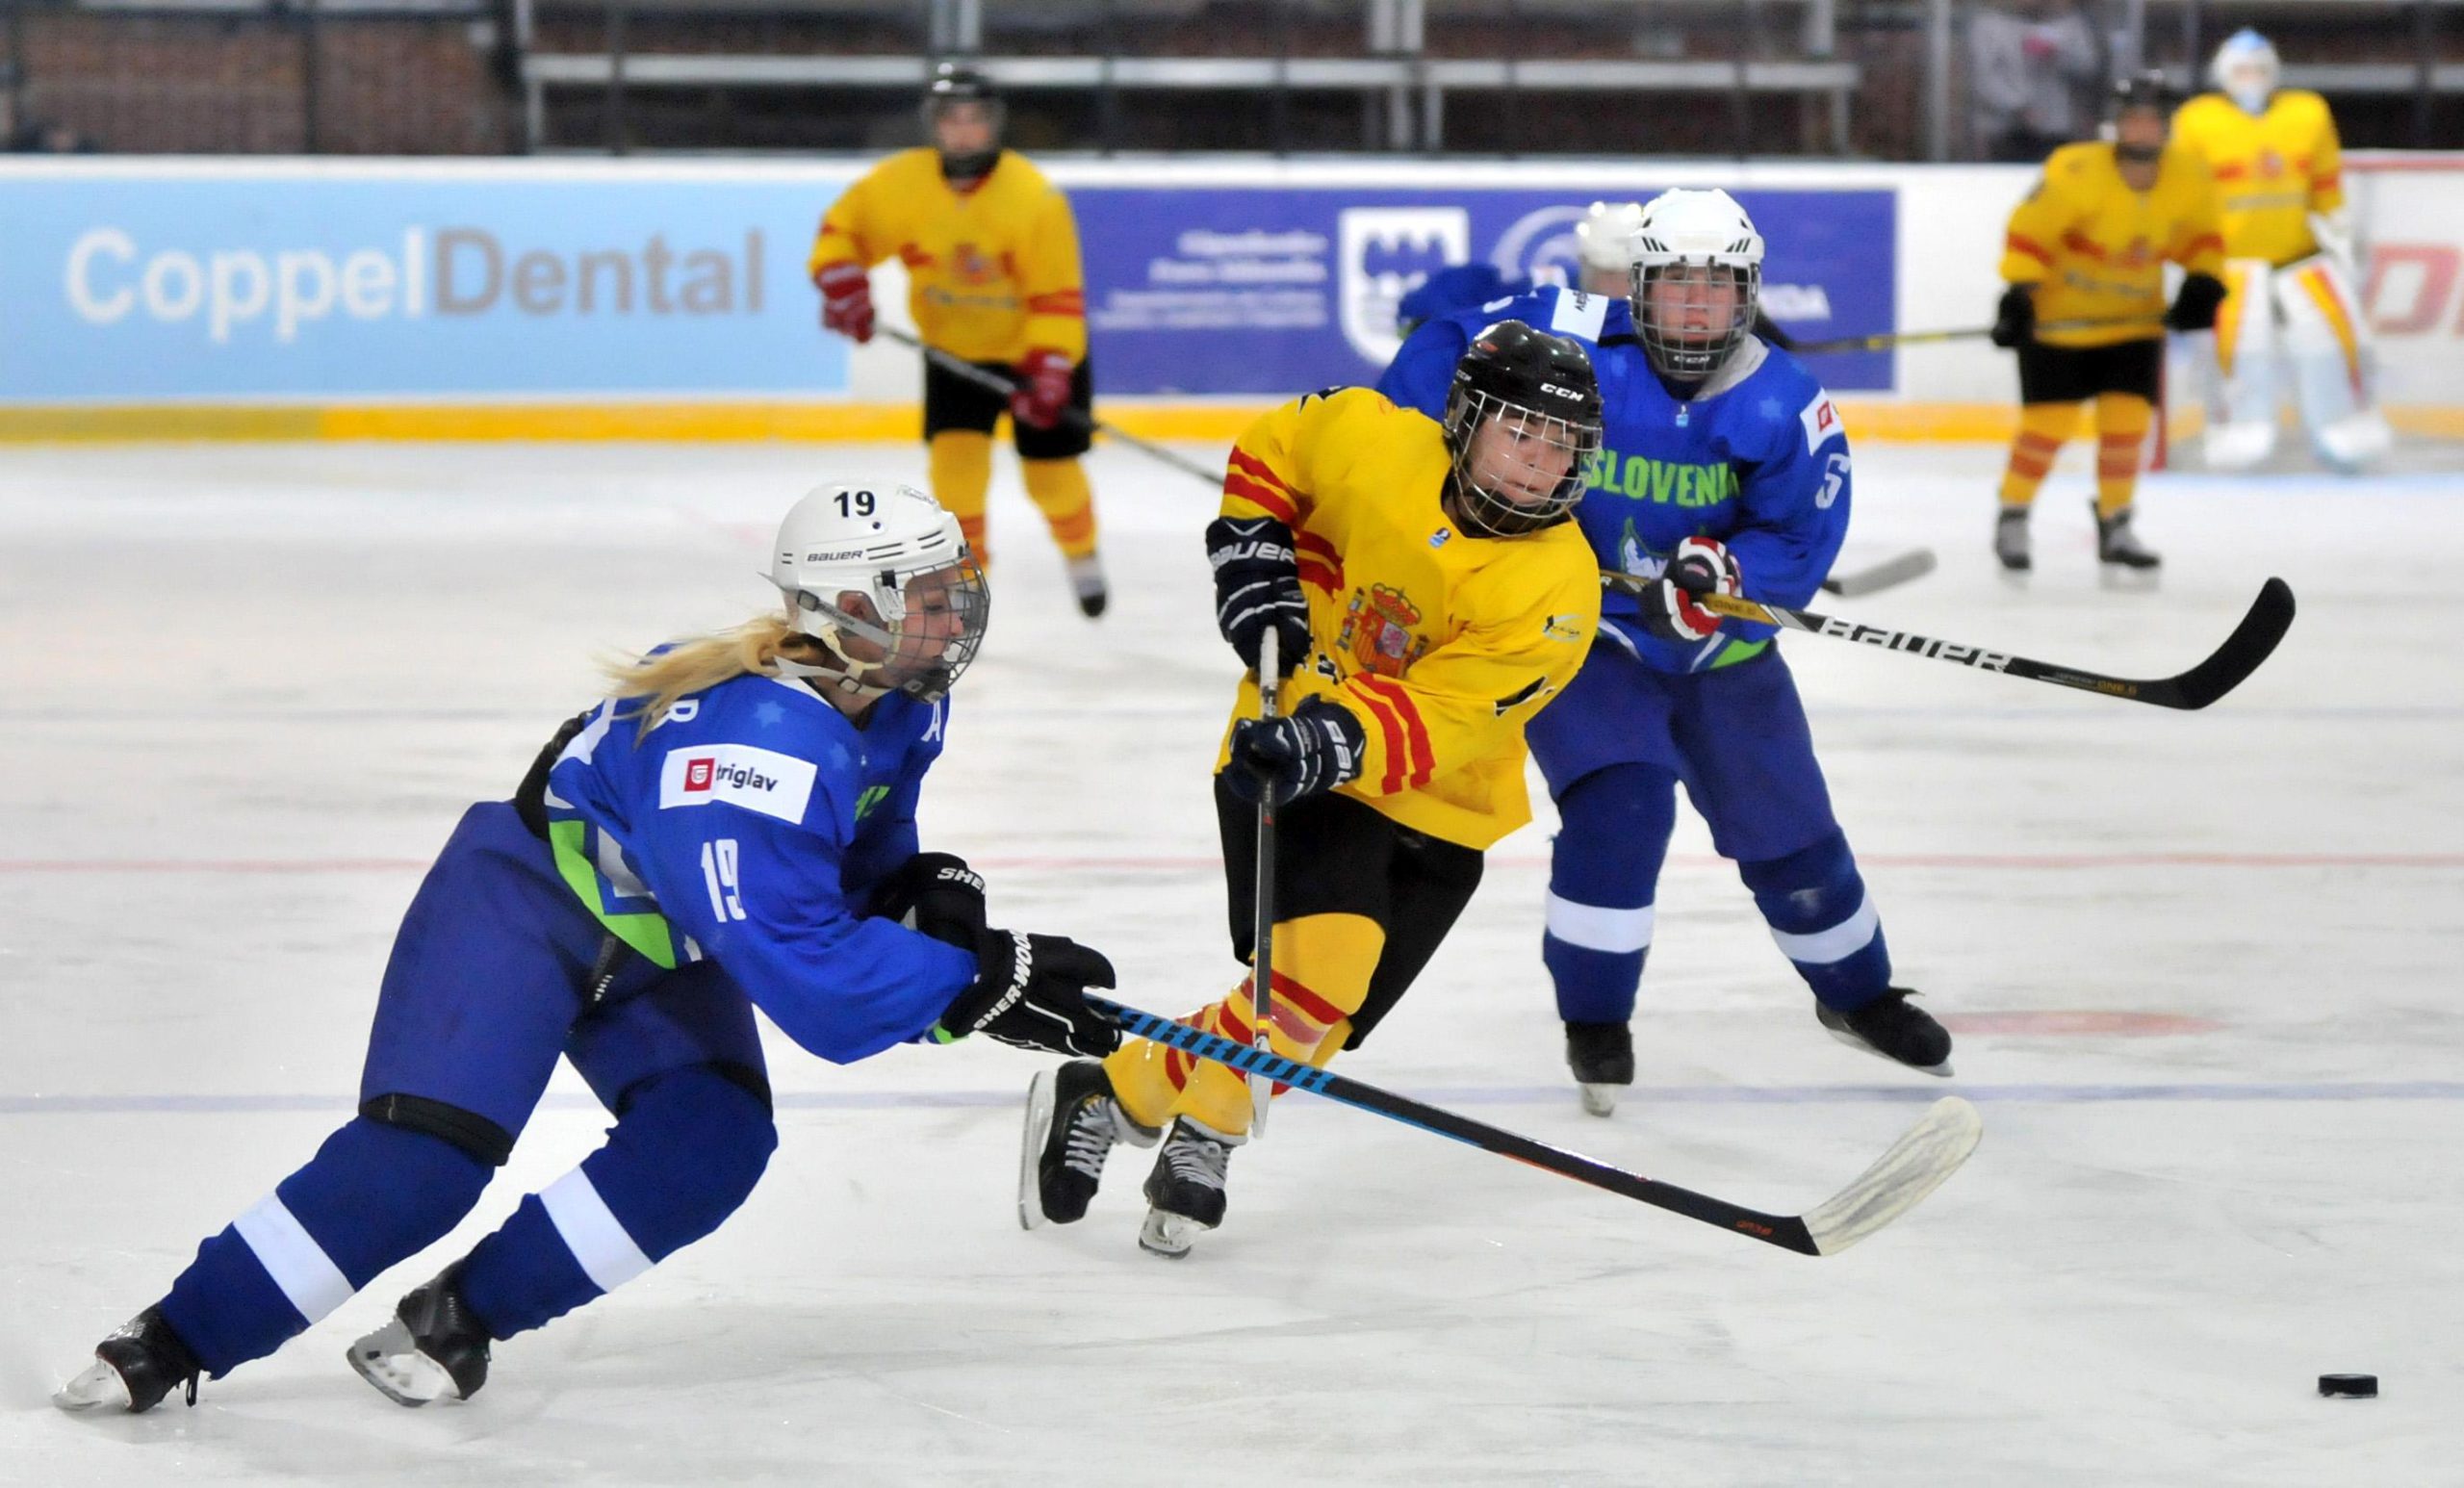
769, 480, 993, 697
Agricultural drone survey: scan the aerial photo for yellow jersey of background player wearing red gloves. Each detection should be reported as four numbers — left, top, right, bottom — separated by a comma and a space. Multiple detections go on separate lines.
806, 150, 1087, 365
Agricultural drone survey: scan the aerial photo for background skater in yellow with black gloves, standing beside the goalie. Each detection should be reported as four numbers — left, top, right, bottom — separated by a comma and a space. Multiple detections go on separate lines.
1993, 74, 2225, 572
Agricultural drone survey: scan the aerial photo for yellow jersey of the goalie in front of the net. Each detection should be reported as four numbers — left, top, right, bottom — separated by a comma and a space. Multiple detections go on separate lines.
2173, 89, 2344, 269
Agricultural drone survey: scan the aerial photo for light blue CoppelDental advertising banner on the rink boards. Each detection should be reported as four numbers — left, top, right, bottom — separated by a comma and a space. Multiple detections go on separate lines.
0, 172, 848, 401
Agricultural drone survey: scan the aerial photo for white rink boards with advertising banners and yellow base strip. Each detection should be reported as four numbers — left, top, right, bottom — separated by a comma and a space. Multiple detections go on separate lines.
0, 155, 2464, 441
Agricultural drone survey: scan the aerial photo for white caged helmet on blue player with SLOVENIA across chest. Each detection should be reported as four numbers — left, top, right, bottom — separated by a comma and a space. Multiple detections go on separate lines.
1631, 188, 1761, 382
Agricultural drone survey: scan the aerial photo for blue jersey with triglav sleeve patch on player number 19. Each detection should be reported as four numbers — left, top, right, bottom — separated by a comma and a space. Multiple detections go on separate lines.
547, 675, 976, 1065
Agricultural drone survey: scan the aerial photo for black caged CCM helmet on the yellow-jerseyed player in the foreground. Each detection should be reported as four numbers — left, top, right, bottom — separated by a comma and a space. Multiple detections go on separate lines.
1447, 321, 1599, 537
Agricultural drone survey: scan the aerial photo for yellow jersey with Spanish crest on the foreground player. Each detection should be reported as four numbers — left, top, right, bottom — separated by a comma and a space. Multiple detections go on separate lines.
1215, 387, 1599, 848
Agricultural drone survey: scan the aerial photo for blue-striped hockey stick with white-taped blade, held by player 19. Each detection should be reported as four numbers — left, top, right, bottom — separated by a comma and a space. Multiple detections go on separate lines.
1087, 995, 1986, 1256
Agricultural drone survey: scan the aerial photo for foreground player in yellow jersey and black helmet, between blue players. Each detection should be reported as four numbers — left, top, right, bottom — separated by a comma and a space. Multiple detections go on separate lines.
1020, 321, 1599, 1254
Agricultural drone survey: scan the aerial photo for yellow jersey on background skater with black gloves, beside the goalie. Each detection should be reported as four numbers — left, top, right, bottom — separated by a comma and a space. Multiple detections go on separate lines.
2001, 141, 2225, 347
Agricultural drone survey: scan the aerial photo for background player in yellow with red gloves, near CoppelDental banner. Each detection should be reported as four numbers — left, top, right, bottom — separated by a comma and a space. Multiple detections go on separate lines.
810, 64, 1106, 618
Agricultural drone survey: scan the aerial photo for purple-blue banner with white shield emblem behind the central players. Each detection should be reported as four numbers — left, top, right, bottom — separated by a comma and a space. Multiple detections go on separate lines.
1069, 185, 1897, 397
